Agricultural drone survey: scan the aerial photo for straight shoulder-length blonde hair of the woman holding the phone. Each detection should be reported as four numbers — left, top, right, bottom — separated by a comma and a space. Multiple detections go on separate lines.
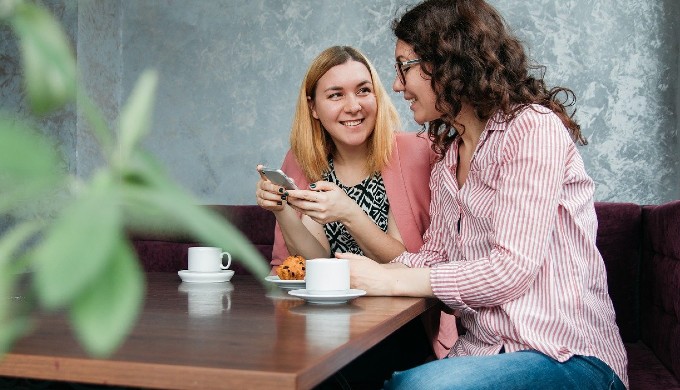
290, 46, 400, 182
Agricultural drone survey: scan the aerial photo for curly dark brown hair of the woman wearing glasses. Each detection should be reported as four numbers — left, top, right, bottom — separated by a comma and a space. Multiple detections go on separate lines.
392, 0, 587, 157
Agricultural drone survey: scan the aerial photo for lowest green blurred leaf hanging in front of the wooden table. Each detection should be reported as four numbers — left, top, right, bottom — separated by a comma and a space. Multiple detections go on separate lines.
70, 240, 145, 357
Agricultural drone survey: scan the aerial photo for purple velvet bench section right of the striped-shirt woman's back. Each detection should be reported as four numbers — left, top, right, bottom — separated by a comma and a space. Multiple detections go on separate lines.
595, 201, 680, 390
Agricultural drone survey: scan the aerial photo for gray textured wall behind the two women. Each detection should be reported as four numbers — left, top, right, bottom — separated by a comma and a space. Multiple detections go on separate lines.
0, 0, 680, 209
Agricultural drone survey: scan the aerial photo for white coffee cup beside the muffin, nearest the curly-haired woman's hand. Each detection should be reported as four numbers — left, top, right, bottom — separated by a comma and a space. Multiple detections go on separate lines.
305, 259, 349, 295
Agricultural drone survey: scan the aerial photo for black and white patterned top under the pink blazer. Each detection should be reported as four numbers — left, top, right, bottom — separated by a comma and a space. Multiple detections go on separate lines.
323, 158, 390, 256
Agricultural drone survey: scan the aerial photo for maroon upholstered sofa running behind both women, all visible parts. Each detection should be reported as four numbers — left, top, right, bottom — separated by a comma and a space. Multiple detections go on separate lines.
133, 201, 680, 390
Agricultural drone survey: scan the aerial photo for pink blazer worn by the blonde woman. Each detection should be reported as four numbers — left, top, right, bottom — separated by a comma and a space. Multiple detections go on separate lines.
271, 133, 458, 358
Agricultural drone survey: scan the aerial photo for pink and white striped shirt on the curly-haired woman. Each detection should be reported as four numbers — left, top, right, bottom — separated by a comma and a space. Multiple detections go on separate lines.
394, 106, 628, 386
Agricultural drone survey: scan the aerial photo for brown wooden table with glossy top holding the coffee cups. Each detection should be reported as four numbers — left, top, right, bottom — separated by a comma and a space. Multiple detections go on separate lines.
0, 273, 435, 389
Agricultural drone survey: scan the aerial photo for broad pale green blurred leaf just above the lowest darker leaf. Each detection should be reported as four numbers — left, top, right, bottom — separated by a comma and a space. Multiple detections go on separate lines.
35, 172, 122, 309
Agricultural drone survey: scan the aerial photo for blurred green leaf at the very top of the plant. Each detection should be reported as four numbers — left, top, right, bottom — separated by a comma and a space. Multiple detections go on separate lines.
10, 2, 76, 114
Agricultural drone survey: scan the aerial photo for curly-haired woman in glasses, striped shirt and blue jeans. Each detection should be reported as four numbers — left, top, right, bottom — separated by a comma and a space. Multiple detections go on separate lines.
338, 0, 628, 389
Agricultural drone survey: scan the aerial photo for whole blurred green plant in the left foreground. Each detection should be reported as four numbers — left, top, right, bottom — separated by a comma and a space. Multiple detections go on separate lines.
0, 0, 268, 357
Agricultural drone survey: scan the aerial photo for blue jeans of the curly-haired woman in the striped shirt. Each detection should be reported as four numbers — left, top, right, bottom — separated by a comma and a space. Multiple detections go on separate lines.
385, 351, 625, 390
